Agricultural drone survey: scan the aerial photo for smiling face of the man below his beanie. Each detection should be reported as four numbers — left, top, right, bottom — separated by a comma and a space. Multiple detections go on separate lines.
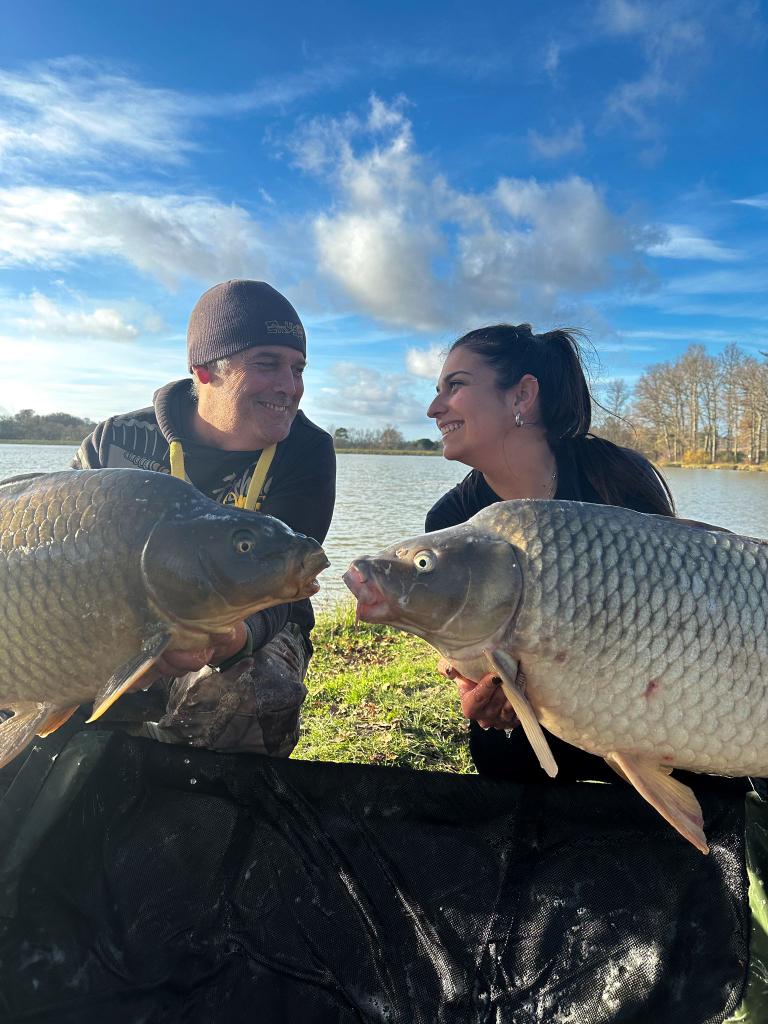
207, 345, 306, 449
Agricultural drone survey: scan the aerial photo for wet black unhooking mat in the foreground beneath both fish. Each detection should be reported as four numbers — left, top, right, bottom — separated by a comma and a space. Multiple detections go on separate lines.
0, 730, 749, 1024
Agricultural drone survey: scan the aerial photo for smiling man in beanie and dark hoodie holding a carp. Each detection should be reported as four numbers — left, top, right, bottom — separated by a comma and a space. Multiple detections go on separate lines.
73, 281, 336, 757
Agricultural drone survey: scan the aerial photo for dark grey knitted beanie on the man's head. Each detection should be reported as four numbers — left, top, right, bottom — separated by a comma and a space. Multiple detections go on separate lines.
186, 281, 306, 370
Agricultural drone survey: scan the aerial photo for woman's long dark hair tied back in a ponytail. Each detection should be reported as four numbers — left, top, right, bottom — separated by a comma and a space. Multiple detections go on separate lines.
451, 324, 675, 515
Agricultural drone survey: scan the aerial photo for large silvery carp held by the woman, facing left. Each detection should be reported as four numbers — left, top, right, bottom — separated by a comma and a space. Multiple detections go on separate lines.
344, 501, 768, 853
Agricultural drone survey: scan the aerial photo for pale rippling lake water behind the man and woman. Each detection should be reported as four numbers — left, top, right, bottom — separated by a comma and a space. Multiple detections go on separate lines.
0, 444, 768, 608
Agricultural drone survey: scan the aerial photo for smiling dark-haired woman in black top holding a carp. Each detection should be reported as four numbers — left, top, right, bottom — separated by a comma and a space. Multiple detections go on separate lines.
426, 324, 675, 781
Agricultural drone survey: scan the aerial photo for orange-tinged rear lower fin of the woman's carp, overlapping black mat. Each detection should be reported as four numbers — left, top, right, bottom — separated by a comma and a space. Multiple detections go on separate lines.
605, 751, 710, 853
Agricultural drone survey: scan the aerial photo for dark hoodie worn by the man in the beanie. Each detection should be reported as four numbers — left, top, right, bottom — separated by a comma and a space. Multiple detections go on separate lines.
72, 379, 336, 650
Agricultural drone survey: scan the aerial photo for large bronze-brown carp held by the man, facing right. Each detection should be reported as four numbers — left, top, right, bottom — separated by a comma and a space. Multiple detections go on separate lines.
0, 469, 329, 767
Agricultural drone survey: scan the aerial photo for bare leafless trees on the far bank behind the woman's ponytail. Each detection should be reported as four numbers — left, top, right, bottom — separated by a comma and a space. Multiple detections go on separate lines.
594, 343, 768, 465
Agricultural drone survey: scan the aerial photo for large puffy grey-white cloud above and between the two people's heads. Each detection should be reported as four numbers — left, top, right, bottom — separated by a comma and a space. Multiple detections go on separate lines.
292, 97, 647, 331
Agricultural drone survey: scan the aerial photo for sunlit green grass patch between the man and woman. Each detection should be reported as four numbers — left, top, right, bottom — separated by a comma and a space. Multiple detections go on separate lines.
293, 604, 474, 773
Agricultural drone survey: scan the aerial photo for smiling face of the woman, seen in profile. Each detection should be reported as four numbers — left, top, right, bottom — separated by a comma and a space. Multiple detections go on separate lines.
427, 346, 516, 468
